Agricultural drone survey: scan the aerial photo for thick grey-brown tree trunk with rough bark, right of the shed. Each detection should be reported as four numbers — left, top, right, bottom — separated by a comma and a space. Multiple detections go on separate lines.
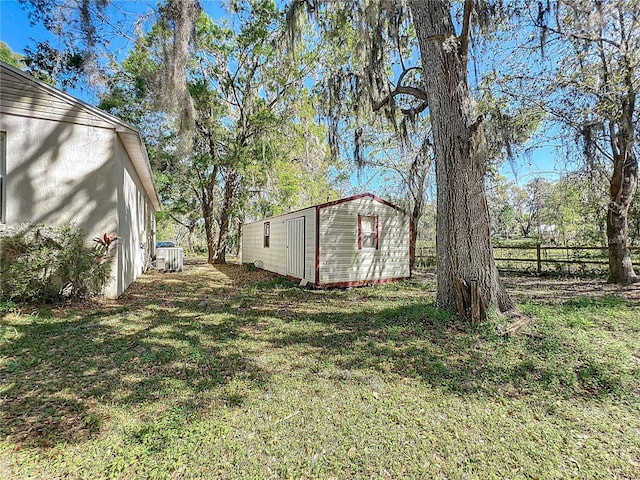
410, 0, 513, 311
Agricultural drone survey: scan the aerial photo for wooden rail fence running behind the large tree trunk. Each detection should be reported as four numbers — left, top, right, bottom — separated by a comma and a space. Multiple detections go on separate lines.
416, 244, 640, 274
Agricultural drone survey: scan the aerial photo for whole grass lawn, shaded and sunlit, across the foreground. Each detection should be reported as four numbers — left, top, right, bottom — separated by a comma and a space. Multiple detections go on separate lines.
0, 264, 640, 479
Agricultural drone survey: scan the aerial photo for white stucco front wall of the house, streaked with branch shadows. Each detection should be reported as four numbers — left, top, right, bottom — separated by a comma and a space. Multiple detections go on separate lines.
0, 114, 117, 236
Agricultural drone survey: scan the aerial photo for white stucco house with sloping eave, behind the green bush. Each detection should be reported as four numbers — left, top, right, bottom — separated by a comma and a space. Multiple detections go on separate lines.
0, 62, 160, 298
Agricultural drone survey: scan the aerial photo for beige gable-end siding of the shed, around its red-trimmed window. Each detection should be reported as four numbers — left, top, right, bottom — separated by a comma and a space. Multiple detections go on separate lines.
320, 197, 409, 284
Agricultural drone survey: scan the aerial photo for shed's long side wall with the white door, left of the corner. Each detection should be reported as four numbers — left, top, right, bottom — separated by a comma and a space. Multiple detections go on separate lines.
242, 207, 316, 283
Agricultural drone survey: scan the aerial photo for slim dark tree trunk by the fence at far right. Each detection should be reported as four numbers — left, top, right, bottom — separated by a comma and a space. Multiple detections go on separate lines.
607, 96, 638, 285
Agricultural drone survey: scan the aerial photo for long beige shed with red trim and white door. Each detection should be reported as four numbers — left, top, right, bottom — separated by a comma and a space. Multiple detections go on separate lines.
242, 193, 411, 287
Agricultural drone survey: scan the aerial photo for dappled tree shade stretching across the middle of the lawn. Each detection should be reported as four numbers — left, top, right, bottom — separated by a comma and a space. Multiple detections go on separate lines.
0, 260, 640, 449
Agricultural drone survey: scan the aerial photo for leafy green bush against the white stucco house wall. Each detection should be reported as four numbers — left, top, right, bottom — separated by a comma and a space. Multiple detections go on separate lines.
0, 225, 115, 302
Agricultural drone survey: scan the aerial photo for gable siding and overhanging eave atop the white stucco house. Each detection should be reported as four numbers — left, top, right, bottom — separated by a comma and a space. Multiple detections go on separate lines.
0, 61, 160, 212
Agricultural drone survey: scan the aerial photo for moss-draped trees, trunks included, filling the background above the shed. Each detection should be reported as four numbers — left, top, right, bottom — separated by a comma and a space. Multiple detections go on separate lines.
11, 0, 640, 310
